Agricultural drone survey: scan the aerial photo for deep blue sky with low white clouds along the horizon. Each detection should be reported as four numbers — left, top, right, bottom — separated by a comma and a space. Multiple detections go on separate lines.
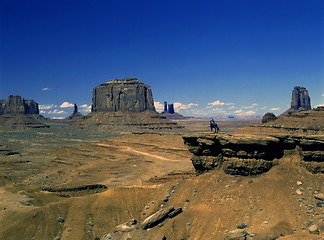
0, 0, 324, 117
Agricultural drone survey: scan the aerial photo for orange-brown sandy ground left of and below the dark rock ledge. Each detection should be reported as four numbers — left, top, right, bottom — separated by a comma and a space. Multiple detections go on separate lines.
0, 120, 324, 240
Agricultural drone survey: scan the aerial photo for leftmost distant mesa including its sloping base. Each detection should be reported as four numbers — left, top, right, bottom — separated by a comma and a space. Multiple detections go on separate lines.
0, 95, 48, 129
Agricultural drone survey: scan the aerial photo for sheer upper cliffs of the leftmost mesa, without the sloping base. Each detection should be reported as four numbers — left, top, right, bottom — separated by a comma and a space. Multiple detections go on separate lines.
0, 95, 39, 115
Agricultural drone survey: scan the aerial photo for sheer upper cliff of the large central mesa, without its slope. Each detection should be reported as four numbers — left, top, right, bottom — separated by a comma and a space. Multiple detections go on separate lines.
91, 78, 155, 112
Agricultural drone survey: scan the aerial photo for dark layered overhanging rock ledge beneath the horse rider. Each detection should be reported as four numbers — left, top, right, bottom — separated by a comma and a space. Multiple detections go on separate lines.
183, 134, 324, 176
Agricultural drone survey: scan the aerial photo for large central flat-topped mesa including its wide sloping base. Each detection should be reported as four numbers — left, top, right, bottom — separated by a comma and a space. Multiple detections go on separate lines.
72, 78, 181, 131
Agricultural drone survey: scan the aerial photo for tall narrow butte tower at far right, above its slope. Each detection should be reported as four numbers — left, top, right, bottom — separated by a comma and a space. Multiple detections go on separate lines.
291, 86, 311, 111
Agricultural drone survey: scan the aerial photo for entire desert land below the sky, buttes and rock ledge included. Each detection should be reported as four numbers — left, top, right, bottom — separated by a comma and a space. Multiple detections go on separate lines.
0, 78, 324, 240
